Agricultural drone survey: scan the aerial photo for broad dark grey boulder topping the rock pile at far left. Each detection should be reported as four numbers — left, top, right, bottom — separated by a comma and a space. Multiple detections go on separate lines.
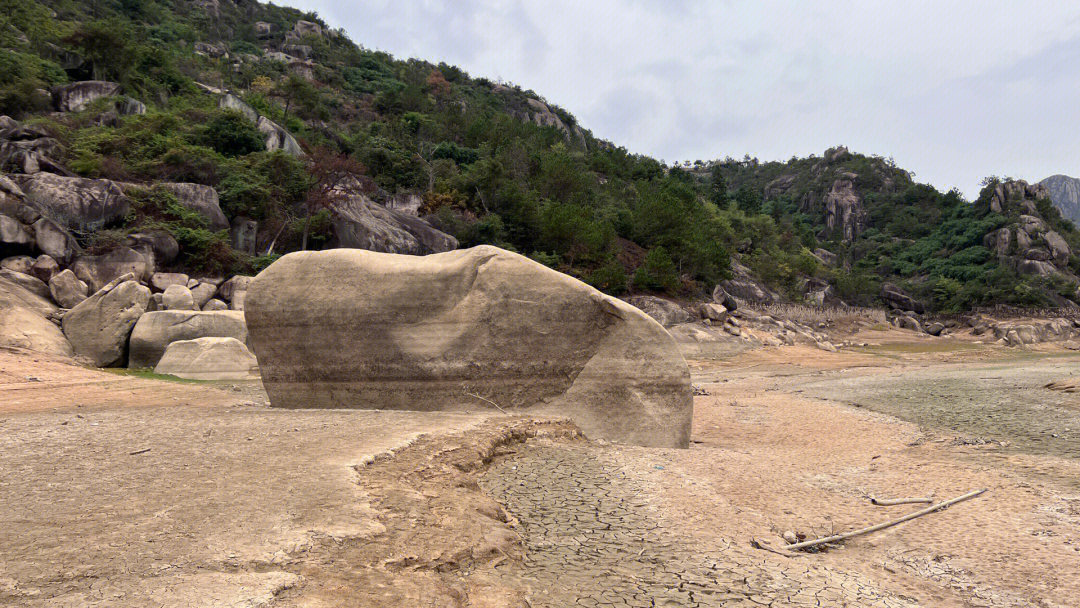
19, 173, 131, 232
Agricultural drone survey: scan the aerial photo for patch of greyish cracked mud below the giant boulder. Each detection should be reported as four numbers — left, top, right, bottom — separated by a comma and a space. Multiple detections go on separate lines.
482, 445, 917, 608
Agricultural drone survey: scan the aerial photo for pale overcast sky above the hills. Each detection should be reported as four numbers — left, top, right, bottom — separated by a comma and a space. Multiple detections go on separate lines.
285, 0, 1080, 197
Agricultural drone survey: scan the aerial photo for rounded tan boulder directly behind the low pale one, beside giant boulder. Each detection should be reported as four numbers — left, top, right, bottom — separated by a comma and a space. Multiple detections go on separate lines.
127, 310, 247, 368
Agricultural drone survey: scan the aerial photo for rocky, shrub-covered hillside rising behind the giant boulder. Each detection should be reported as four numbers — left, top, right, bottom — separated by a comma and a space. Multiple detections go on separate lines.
0, 0, 1080, 311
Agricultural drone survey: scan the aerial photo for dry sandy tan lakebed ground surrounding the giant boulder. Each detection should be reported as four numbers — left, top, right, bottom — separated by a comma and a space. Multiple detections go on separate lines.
0, 333, 1080, 608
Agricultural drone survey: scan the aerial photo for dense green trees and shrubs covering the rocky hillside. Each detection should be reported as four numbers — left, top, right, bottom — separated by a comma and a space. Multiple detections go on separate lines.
0, 0, 1080, 309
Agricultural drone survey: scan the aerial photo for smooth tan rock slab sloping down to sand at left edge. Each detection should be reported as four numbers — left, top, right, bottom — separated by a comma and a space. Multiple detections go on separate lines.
0, 275, 72, 356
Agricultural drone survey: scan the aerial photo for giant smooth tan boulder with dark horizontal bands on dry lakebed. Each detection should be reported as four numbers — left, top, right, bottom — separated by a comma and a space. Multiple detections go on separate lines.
247, 246, 693, 447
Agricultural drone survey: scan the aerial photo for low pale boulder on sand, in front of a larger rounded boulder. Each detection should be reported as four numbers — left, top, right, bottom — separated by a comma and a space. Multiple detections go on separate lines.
153, 338, 259, 380
